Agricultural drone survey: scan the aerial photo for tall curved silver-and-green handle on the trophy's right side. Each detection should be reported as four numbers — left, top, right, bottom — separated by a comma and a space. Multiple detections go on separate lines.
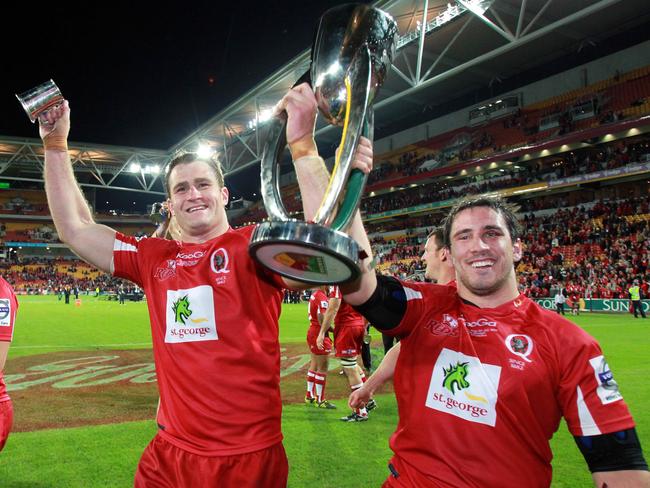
314, 46, 374, 230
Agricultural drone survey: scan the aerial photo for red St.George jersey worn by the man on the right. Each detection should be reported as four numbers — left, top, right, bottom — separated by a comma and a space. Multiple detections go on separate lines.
382, 283, 634, 487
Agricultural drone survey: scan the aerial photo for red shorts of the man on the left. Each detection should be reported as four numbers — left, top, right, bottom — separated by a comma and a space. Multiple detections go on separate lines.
133, 435, 289, 488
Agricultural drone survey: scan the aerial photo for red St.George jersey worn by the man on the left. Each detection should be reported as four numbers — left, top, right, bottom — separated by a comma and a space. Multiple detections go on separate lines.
113, 227, 284, 456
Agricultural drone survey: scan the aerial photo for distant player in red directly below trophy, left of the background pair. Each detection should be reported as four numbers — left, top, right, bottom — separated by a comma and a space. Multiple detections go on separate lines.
305, 285, 339, 409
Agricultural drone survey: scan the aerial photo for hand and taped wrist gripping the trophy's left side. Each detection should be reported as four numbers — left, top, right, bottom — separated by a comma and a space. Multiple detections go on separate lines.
275, 83, 318, 161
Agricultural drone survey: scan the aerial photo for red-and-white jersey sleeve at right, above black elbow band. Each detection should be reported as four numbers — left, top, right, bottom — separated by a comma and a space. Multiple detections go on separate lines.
558, 324, 634, 436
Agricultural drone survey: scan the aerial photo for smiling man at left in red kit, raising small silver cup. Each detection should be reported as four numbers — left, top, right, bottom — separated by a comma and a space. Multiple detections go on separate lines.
39, 87, 367, 488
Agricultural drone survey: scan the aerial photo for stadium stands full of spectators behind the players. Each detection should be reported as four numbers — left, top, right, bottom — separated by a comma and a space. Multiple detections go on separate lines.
0, 62, 650, 298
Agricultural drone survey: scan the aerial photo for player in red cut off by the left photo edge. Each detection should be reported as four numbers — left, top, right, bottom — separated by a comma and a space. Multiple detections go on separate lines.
0, 277, 18, 451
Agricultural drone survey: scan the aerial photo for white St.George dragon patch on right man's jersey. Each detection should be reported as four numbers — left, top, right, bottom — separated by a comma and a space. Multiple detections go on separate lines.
425, 348, 501, 427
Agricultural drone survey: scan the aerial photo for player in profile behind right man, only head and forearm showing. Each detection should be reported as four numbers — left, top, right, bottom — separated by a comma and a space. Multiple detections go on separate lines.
348, 227, 456, 409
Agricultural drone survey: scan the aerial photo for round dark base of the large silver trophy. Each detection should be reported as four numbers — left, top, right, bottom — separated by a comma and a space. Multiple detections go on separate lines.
248, 220, 360, 285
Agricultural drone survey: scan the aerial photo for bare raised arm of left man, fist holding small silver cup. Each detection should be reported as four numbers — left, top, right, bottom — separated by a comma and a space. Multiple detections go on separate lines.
39, 101, 115, 272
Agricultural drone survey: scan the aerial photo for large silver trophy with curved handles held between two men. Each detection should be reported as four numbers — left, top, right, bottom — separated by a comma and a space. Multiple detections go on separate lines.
249, 4, 397, 284
